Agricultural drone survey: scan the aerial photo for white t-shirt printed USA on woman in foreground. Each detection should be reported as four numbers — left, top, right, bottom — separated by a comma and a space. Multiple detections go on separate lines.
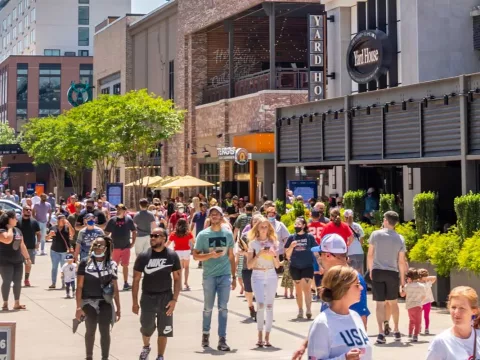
308, 309, 373, 360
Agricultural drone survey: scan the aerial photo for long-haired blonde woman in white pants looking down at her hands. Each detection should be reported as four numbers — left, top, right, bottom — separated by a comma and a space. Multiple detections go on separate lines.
247, 216, 280, 347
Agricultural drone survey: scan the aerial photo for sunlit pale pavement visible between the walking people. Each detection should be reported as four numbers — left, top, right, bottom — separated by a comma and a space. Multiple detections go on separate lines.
0, 244, 450, 360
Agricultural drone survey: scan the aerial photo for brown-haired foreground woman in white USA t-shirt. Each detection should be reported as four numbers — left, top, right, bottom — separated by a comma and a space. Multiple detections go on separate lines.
308, 265, 373, 360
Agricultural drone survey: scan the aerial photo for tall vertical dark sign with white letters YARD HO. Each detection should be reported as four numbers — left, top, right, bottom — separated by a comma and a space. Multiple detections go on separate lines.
308, 15, 325, 101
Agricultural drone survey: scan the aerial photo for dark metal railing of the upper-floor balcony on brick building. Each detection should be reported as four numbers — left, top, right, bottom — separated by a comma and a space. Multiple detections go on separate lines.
202, 68, 308, 104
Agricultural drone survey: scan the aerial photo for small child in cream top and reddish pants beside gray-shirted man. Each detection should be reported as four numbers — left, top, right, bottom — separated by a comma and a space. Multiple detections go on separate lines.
400, 268, 426, 342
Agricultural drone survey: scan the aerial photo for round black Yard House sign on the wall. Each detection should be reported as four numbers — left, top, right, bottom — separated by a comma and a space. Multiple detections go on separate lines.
347, 30, 393, 84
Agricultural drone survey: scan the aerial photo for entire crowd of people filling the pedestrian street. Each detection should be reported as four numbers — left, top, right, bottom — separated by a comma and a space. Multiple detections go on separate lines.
0, 190, 480, 360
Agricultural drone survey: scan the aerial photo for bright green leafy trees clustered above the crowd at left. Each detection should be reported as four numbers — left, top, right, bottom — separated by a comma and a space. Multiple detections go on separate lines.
22, 89, 184, 198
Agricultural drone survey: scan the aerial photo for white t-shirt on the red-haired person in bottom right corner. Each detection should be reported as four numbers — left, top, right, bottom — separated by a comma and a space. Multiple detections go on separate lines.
427, 328, 480, 360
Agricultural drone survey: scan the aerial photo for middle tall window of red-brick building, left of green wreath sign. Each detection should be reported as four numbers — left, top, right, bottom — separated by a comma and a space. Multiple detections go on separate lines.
38, 64, 61, 111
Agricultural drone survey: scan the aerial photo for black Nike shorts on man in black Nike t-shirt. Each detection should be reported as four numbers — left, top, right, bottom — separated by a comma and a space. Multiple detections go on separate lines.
140, 292, 173, 337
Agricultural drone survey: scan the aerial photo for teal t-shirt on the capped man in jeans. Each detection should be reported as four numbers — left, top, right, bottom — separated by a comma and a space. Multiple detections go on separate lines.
195, 227, 233, 278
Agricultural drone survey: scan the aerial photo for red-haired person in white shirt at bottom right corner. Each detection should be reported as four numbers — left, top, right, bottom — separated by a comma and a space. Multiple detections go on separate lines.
427, 286, 480, 360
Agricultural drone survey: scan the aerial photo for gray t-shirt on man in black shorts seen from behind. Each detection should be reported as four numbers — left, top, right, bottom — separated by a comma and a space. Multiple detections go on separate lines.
368, 229, 406, 272
